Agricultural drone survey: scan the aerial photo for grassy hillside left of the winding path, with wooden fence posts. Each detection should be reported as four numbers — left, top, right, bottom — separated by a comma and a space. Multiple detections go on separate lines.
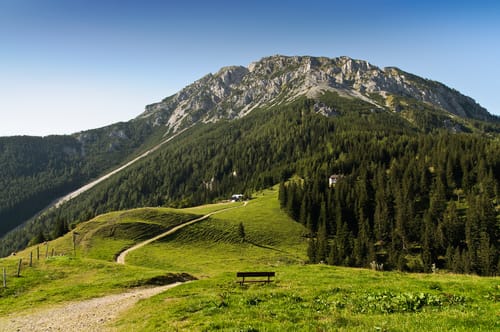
0, 208, 203, 314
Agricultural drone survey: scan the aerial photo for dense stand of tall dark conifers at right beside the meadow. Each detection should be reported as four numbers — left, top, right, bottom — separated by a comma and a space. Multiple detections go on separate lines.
280, 133, 500, 275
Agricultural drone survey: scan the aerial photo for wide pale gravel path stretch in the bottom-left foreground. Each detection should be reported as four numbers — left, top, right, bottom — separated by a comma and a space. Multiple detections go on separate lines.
0, 282, 182, 332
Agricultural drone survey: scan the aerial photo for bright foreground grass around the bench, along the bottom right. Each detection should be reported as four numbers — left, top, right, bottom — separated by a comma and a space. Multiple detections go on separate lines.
115, 265, 500, 331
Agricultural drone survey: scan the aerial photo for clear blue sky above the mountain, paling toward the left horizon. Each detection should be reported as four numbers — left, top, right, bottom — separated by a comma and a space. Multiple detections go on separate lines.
0, 0, 500, 136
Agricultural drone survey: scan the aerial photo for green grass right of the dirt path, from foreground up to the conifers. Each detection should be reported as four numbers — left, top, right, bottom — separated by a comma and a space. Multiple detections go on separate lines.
115, 191, 500, 331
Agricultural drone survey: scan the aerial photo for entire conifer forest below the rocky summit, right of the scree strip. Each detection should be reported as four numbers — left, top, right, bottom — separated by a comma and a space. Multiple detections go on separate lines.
0, 94, 500, 275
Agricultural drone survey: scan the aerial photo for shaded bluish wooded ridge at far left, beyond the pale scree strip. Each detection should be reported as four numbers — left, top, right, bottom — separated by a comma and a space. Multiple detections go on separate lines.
0, 122, 158, 236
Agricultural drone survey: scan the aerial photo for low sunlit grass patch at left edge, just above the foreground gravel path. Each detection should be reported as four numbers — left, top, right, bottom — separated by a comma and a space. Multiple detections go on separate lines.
0, 256, 182, 315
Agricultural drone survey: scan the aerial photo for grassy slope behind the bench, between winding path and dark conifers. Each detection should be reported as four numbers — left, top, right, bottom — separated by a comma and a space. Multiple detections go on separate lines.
127, 190, 307, 277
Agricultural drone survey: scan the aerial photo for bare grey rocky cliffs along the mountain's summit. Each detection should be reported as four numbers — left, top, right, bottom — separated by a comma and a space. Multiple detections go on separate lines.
139, 55, 491, 131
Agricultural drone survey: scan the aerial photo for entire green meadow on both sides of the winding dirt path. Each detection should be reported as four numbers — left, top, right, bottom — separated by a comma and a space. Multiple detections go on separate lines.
0, 189, 500, 331
